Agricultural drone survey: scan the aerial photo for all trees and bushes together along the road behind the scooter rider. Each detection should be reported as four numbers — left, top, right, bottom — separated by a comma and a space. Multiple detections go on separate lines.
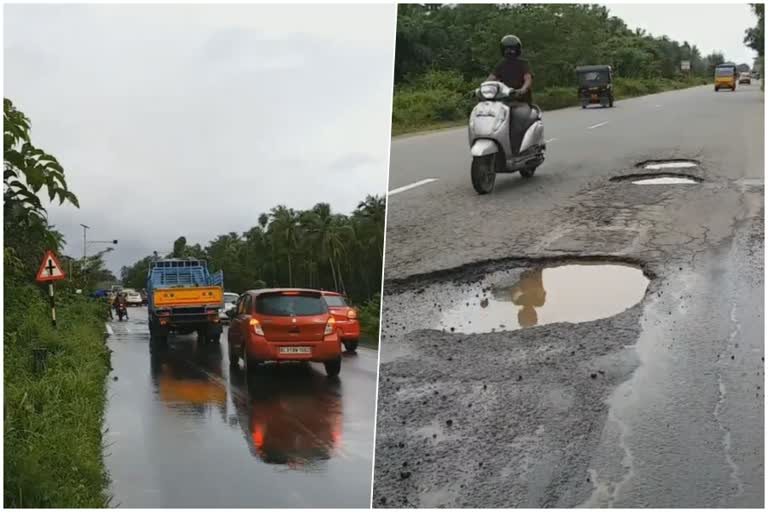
392, 4, 736, 135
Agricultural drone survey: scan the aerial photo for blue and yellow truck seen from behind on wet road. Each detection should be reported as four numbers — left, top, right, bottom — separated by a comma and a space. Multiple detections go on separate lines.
147, 258, 224, 344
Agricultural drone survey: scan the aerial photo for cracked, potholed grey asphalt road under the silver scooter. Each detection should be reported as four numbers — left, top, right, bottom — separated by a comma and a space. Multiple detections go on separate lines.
373, 87, 764, 508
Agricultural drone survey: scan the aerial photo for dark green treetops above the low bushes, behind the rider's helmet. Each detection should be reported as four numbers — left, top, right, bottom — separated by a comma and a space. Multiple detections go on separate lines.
395, 4, 736, 89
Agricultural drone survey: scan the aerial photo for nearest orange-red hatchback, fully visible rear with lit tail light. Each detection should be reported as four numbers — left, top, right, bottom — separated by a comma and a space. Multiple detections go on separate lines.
227, 288, 341, 377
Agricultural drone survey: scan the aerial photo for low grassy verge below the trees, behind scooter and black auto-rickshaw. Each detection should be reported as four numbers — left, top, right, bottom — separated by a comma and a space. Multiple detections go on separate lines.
392, 71, 710, 137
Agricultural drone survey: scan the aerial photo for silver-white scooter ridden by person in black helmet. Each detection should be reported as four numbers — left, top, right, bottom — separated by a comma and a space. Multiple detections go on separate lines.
469, 82, 547, 194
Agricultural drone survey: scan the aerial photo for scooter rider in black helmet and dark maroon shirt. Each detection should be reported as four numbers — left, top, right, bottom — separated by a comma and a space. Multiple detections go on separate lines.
488, 34, 533, 152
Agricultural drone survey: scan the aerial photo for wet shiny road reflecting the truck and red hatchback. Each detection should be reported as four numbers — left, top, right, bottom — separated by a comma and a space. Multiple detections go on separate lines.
105, 308, 376, 508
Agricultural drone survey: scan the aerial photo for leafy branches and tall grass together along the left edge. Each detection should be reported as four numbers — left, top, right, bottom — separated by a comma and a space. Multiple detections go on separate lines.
3, 99, 109, 508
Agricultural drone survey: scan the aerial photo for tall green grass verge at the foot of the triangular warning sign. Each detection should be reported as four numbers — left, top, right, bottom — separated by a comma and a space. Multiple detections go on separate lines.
3, 279, 110, 508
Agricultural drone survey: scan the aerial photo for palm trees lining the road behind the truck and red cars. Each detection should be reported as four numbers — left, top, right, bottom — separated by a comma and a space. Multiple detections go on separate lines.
121, 196, 385, 344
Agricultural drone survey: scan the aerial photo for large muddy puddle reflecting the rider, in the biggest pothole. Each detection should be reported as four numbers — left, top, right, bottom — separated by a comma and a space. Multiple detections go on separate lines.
437, 264, 648, 334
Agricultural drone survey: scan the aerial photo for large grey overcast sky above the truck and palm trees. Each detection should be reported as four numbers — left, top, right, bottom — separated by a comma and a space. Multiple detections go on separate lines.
4, 4, 395, 271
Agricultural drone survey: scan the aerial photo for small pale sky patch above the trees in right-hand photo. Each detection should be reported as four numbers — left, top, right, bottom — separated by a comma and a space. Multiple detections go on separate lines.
606, 3, 757, 66
